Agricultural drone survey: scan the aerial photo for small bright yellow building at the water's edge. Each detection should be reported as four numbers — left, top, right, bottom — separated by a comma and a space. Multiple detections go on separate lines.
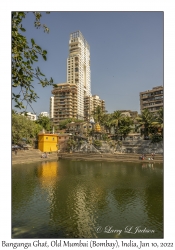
38, 133, 58, 152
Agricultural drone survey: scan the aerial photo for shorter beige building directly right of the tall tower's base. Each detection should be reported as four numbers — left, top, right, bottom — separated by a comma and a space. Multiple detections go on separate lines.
84, 95, 105, 121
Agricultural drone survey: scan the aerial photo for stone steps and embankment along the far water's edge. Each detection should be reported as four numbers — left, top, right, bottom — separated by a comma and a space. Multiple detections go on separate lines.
12, 149, 163, 165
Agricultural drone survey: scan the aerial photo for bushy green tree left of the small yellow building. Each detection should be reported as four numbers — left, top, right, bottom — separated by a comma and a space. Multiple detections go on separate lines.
12, 114, 42, 144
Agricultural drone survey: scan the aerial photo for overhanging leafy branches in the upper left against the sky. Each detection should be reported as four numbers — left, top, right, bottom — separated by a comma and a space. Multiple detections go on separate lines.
12, 12, 55, 109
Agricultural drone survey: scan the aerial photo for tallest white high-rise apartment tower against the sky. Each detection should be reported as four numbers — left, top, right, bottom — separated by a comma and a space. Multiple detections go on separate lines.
67, 31, 91, 119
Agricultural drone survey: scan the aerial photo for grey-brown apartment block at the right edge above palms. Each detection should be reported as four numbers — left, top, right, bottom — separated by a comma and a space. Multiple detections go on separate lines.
140, 86, 163, 112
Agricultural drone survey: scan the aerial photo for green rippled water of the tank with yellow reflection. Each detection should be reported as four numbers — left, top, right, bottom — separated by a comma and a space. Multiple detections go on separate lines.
12, 159, 163, 239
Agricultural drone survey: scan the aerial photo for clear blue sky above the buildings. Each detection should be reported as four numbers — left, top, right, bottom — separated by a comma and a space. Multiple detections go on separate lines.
12, 11, 164, 115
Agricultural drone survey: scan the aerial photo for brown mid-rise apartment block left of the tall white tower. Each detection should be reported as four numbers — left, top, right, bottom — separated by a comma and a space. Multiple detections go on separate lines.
52, 83, 77, 125
